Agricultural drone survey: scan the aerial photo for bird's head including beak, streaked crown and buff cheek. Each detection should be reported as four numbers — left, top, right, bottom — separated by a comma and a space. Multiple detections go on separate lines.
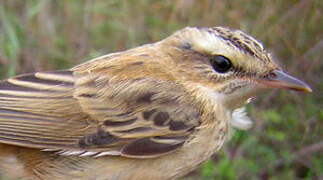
160, 27, 312, 109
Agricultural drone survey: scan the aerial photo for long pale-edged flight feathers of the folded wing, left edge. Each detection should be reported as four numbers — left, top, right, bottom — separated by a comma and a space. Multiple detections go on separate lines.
0, 71, 88, 148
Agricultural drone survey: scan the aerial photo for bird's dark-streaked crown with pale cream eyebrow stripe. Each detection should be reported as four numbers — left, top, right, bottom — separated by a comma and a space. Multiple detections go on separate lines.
171, 27, 280, 76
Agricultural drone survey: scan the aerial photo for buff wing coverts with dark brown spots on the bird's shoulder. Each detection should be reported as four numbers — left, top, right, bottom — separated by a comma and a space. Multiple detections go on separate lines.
75, 71, 200, 158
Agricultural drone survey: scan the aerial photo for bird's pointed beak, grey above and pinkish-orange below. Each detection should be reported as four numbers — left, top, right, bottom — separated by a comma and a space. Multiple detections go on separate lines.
257, 70, 312, 93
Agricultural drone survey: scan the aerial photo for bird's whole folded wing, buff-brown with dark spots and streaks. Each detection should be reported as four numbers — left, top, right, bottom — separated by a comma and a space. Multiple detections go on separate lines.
0, 71, 199, 158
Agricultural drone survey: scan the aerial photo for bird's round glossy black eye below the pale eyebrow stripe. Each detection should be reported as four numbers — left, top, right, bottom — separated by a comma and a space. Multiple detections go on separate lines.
210, 55, 232, 73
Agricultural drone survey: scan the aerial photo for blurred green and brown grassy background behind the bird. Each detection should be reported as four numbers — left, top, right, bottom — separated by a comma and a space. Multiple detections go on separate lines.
0, 0, 323, 180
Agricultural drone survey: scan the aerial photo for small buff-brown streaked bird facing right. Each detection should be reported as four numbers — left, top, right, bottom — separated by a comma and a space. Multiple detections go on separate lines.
0, 26, 312, 180
